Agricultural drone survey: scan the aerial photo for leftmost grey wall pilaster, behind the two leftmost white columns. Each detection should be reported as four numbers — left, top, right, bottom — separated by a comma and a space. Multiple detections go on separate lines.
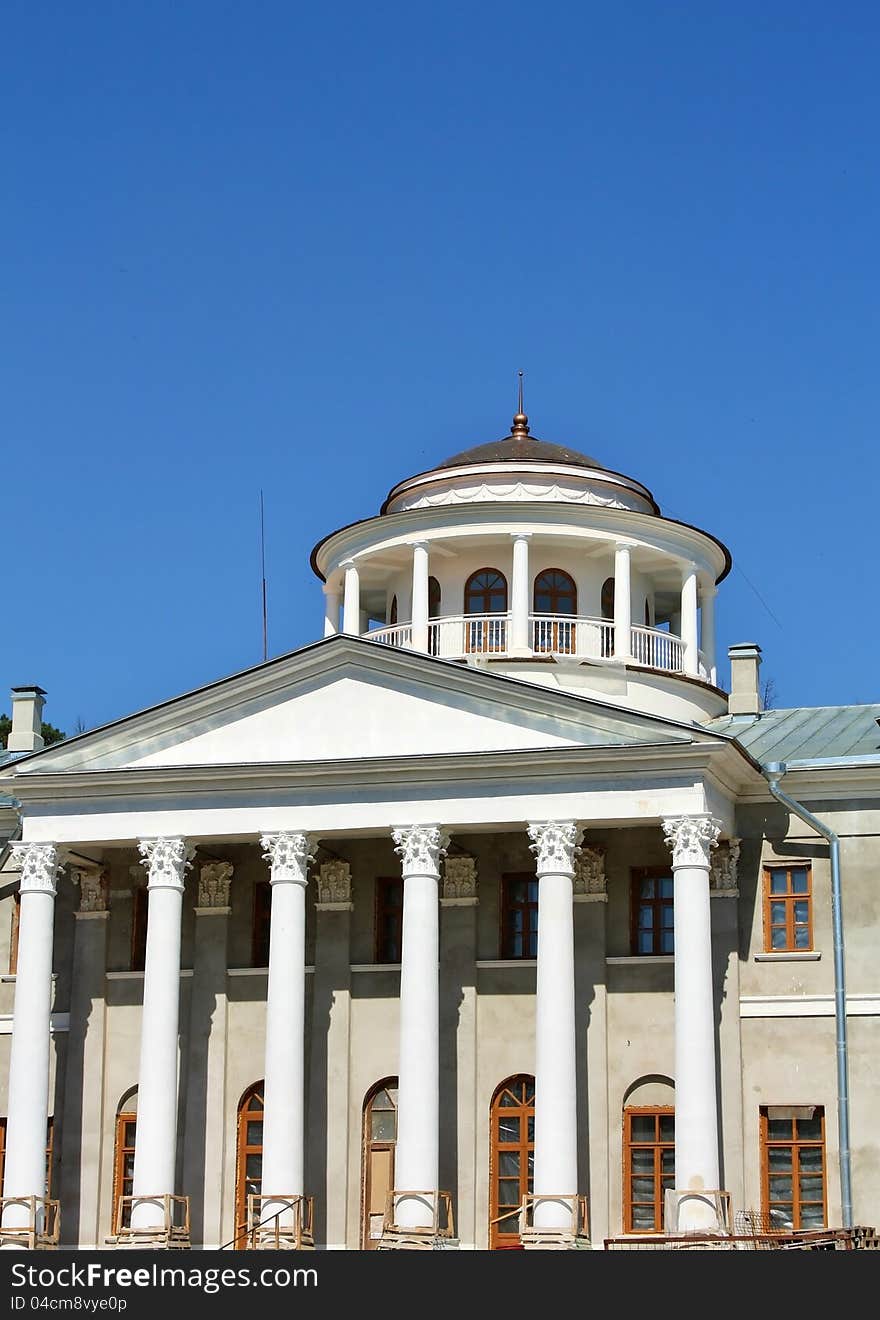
61, 866, 110, 1247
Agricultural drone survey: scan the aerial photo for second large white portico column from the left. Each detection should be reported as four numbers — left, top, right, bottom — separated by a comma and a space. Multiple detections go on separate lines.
132, 838, 194, 1229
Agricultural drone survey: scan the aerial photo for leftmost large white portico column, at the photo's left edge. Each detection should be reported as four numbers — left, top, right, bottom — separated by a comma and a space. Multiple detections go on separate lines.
3, 843, 58, 1245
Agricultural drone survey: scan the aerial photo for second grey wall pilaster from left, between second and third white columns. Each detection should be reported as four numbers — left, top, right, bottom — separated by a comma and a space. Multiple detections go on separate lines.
183, 861, 235, 1249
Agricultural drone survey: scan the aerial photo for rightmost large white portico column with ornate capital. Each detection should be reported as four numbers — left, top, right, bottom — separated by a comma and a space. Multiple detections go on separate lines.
662, 814, 720, 1229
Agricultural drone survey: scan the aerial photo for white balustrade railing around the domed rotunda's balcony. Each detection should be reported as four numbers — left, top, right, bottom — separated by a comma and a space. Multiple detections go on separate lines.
363, 612, 710, 681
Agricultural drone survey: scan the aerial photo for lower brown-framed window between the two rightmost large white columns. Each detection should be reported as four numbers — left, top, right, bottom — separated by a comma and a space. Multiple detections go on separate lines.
623, 1106, 676, 1233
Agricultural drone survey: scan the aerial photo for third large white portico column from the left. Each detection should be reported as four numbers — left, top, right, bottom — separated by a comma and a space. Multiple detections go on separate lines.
260, 833, 313, 1228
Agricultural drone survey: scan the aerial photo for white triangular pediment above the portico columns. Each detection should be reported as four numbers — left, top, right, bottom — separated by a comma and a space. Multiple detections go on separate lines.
0, 638, 699, 775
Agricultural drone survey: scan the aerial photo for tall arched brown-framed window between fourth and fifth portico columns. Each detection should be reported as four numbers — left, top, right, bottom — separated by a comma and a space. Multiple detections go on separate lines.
489, 1073, 534, 1251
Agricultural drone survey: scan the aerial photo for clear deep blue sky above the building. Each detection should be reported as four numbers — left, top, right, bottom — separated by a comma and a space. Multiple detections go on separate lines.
0, 0, 880, 733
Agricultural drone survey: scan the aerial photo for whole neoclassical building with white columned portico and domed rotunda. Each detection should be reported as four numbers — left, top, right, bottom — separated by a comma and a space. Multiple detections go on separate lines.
0, 409, 880, 1250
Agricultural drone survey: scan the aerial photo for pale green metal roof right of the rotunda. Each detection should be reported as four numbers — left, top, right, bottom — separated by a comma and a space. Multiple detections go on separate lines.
706, 705, 880, 764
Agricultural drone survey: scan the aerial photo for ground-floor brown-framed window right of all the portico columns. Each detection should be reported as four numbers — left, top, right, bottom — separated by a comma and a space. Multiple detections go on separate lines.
760, 1105, 826, 1229
